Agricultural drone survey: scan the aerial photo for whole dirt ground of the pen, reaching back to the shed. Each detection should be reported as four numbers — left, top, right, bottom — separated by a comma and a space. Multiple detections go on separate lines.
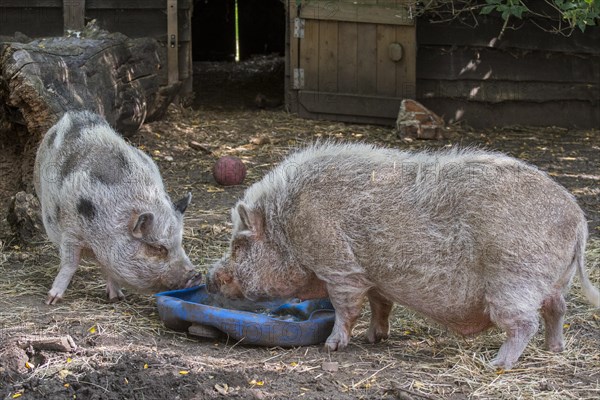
0, 60, 600, 400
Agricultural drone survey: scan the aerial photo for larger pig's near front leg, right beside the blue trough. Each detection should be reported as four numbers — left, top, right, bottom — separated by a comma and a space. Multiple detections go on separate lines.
324, 284, 366, 351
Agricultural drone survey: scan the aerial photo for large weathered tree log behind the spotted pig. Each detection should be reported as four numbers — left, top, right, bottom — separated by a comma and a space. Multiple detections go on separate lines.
0, 23, 180, 242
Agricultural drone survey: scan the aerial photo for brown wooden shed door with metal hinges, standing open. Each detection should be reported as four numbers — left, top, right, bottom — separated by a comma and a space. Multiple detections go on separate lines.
287, 0, 416, 124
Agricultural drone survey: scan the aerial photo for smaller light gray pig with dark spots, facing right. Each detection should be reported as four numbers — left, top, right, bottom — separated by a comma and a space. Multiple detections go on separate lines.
34, 111, 198, 304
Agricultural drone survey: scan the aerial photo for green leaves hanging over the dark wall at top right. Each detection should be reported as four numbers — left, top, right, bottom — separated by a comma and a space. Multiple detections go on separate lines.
479, 0, 600, 32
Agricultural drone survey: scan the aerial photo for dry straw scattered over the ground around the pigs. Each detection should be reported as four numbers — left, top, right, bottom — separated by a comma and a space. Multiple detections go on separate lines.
0, 110, 600, 399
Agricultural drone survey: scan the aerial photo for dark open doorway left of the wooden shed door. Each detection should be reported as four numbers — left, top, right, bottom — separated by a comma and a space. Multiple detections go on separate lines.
192, 0, 286, 109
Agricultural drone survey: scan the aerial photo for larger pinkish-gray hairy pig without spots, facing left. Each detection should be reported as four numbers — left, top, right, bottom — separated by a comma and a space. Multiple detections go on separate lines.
207, 143, 600, 368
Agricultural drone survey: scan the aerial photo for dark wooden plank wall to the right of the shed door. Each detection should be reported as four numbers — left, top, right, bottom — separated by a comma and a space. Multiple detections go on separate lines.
417, 17, 600, 128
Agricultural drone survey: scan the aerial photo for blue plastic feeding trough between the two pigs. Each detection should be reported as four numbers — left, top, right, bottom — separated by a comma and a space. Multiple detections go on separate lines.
155, 285, 335, 347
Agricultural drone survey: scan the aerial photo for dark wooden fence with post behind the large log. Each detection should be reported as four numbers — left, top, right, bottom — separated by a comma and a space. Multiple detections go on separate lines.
0, 0, 193, 93
